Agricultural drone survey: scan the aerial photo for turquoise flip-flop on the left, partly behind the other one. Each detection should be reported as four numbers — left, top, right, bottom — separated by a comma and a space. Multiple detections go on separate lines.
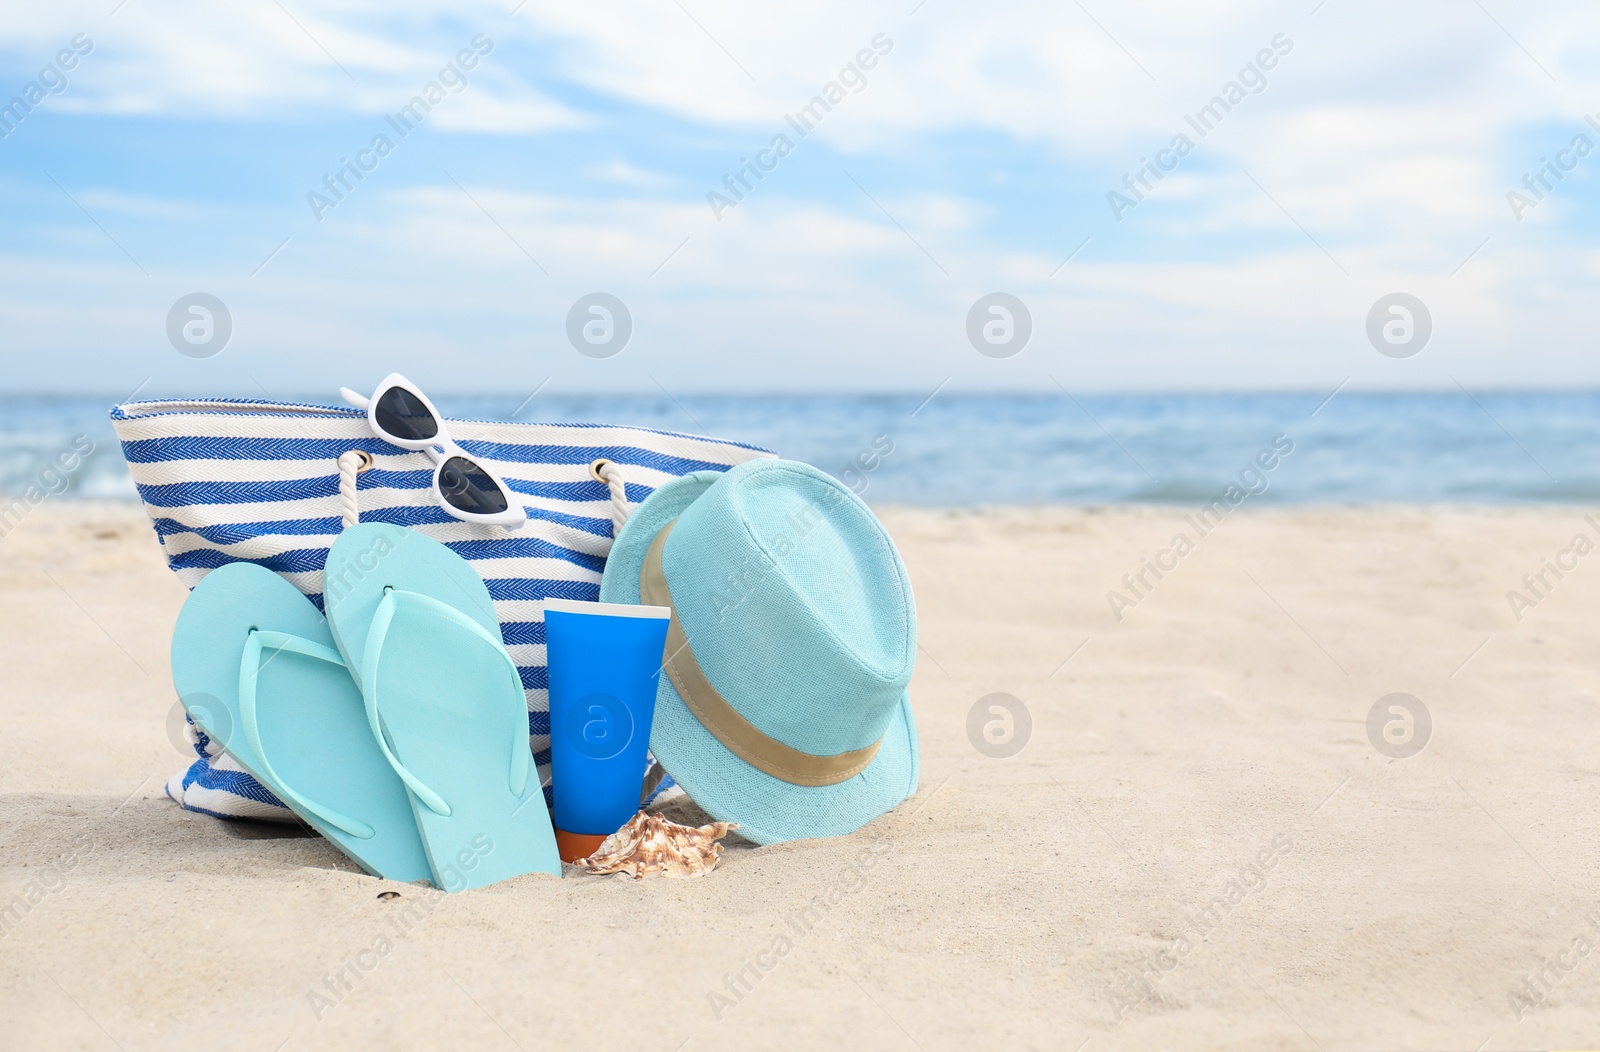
173, 563, 432, 883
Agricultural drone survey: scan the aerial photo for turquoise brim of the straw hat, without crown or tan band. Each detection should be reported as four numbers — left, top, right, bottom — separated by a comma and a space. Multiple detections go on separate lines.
600, 472, 918, 844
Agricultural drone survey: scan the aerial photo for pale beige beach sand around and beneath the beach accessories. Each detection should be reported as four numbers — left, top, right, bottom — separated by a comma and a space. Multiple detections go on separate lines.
0, 504, 1600, 1052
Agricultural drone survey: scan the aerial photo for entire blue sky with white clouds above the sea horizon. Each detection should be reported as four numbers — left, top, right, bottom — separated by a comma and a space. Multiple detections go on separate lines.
0, 0, 1600, 396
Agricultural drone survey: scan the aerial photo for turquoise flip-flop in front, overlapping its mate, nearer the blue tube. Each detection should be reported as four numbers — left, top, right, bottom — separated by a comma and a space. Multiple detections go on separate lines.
323, 523, 562, 892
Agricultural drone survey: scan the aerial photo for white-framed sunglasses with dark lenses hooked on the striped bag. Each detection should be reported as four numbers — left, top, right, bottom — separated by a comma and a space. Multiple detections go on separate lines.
339, 373, 528, 529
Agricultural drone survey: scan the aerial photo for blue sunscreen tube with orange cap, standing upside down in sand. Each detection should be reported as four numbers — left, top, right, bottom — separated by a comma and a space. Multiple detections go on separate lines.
544, 600, 672, 862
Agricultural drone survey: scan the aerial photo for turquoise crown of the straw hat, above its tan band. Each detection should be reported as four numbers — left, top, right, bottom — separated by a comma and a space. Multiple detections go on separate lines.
662, 460, 917, 756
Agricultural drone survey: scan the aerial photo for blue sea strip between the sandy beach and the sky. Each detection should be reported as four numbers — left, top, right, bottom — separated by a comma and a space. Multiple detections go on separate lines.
9, 390, 1600, 507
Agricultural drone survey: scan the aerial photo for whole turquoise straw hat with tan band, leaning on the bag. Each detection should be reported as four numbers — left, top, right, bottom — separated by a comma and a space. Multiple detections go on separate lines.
600, 459, 917, 844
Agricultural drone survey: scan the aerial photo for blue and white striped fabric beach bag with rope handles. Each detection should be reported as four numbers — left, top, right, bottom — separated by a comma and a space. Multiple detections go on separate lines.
110, 398, 773, 822
